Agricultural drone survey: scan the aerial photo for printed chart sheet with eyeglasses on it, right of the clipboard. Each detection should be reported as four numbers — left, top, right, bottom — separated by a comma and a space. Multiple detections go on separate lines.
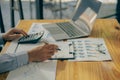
69, 38, 112, 61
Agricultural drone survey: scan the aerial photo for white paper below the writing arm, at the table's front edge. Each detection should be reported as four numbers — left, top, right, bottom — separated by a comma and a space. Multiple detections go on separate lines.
6, 61, 57, 80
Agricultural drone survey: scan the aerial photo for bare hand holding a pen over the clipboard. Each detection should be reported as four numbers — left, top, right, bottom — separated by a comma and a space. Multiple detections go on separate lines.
28, 44, 58, 62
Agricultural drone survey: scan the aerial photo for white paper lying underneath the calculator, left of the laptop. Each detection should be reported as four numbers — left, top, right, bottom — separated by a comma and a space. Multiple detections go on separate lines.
6, 23, 56, 54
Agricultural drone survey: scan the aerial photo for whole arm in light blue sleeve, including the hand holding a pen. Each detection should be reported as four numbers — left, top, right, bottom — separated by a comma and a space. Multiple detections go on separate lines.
0, 44, 57, 73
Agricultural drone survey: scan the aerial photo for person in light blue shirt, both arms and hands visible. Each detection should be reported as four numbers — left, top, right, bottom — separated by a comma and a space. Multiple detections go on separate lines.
0, 28, 58, 73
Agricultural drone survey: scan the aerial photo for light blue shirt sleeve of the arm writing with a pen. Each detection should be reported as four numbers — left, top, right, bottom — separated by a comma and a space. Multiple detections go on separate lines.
0, 52, 28, 73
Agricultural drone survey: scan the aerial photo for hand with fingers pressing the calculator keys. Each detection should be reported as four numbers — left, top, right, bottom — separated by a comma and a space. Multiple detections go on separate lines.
2, 28, 27, 41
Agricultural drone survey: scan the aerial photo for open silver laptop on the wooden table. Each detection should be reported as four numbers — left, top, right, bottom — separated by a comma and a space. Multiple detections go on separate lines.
43, 0, 101, 40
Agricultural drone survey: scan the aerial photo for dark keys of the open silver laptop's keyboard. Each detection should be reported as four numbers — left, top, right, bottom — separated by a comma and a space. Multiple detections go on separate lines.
56, 22, 83, 37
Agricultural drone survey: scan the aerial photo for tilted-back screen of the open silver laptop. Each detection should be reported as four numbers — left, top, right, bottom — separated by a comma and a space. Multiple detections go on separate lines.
72, 0, 101, 31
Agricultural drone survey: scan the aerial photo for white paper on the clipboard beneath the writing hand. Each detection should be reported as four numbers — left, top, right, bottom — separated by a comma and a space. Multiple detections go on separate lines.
16, 42, 74, 60
